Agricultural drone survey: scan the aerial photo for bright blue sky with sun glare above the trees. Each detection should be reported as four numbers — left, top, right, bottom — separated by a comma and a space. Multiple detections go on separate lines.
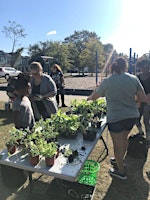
0, 0, 150, 57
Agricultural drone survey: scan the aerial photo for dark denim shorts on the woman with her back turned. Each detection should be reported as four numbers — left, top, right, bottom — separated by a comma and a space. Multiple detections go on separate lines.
107, 118, 137, 133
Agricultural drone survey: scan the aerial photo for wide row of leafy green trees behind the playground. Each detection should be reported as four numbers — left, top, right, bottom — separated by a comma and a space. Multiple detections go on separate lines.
28, 30, 113, 73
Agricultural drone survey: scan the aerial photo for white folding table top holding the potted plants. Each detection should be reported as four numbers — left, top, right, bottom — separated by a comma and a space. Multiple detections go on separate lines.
0, 117, 106, 182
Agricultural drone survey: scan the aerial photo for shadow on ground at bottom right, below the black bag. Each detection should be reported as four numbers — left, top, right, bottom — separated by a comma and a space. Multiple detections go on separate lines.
103, 152, 149, 200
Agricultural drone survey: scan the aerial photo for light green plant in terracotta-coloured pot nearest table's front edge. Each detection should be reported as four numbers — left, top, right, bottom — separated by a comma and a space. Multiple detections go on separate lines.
42, 142, 57, 167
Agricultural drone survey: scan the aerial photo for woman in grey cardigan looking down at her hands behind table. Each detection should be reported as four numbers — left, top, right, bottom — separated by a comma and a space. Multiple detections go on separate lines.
30, 62, 57, 120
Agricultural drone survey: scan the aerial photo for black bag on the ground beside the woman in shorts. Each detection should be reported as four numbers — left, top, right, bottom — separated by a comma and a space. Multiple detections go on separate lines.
127, 134, 148, 158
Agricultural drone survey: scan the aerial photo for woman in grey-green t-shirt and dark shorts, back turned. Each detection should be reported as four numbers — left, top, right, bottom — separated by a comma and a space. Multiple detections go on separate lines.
87, 57, 147, 180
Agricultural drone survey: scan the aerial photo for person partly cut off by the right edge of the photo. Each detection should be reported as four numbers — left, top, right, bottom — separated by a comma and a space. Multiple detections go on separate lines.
136, 58, 150, 144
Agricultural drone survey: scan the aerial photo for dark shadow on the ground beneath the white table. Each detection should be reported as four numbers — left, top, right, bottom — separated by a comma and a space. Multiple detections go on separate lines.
0, 168, 95, 200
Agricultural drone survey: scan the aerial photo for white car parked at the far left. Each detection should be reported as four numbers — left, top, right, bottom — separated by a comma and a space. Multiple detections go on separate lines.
0, 67, 22, 80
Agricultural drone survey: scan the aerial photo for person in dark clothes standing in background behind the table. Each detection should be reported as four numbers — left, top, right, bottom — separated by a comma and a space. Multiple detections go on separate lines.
50, 64, 67, 107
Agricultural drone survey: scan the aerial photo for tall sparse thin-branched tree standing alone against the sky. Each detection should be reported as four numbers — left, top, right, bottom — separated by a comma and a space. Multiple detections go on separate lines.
2, 21, 26, 53
